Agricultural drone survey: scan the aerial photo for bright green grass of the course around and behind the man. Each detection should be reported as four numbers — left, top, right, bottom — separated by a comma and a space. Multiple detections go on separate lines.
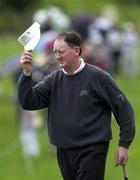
0, 34, 140, 180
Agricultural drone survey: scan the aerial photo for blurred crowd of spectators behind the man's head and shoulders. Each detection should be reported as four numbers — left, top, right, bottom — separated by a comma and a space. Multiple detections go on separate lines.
33, 7, 139, 77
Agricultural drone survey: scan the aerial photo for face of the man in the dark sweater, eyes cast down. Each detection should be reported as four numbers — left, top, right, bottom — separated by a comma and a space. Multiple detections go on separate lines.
53, 39, 80, 69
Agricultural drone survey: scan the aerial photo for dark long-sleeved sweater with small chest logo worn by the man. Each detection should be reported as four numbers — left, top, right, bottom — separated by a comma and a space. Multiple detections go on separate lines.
18, 64, 135, 148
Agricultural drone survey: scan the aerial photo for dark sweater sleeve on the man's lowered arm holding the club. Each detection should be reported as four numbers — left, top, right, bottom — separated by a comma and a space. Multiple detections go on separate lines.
96, 73, 135, 148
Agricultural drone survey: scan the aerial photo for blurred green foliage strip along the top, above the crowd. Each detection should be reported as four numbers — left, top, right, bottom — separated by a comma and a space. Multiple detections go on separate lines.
0, 0, 140, 33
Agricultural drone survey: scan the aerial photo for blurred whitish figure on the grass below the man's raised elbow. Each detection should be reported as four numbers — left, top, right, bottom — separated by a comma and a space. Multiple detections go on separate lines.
20, 110, 42, 157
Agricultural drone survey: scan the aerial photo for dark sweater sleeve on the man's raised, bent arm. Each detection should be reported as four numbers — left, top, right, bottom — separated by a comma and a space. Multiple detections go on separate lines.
17, 74, 50, 110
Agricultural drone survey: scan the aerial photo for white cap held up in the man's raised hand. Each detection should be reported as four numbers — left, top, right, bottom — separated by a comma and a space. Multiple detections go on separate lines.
18, 22, 40, 50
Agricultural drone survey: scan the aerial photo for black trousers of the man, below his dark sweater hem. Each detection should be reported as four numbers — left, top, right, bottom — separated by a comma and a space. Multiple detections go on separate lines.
57, 142, 109, 180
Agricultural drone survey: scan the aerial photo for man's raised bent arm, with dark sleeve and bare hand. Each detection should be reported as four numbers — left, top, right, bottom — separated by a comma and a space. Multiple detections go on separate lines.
18, 51, 49, 110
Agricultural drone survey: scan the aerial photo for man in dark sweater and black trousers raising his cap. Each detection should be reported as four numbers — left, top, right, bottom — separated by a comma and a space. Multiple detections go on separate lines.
18, 32, 135, 180
